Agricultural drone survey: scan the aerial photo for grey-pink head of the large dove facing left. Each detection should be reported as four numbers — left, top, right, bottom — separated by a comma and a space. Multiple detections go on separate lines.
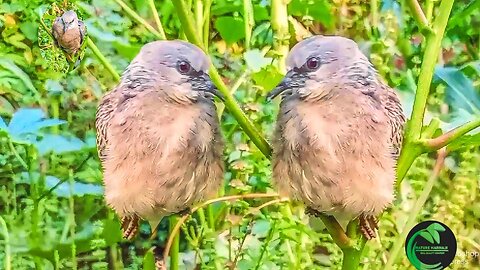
267, 36, 368, 99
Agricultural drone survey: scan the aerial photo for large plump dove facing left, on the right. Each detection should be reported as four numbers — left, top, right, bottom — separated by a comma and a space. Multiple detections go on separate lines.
268, 36, 405, 239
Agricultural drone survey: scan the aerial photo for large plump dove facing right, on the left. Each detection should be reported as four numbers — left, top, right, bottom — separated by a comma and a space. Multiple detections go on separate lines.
96, 41, 224, 239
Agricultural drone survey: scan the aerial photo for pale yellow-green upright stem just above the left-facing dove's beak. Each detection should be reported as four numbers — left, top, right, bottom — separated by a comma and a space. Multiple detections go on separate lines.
271, 0, 290, 73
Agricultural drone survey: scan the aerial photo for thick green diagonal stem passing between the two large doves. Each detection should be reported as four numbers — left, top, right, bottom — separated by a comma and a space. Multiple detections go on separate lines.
172, 0, 271, 158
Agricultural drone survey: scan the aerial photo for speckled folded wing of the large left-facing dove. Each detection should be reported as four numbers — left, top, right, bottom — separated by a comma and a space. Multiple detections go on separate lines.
383, 86, 405, 158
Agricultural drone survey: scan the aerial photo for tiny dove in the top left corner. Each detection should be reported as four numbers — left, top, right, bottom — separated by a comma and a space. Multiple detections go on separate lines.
52, 10, 87, 55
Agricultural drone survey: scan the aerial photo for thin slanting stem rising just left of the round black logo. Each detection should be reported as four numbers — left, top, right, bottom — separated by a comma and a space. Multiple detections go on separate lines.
385, 149, 446, 269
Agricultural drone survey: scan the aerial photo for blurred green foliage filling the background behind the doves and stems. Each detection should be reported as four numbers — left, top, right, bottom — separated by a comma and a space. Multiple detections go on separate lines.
0, 0, 480, 269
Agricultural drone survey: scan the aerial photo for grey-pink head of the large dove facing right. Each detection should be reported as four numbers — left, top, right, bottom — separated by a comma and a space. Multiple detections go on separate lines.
122, 40, 223, 100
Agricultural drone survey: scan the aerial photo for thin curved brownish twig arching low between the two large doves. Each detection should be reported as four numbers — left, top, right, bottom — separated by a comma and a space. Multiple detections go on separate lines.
163, 193, 278, 265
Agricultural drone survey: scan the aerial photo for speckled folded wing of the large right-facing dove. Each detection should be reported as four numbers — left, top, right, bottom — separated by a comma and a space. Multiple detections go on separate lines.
95, 90, 118, 162
